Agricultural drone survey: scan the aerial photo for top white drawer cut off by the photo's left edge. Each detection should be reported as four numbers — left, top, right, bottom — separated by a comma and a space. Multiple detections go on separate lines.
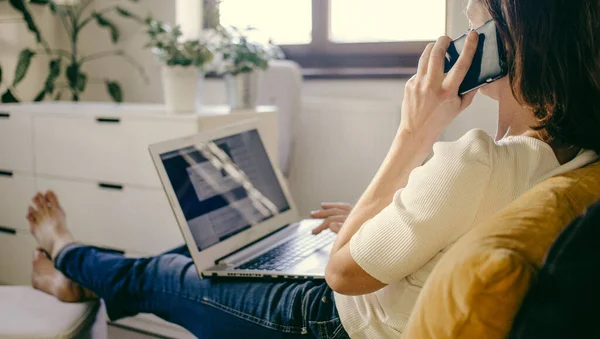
0, 113, 33, 173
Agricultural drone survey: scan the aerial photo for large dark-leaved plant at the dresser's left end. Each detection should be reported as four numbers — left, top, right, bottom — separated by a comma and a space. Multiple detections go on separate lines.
0, 0, 148, 102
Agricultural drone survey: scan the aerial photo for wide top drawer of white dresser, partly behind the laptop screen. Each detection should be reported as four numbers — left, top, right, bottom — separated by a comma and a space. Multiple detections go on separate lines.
33, 116, 197, 188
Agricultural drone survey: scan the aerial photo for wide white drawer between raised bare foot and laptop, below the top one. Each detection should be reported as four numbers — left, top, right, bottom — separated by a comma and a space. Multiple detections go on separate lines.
37, 178, 184, 254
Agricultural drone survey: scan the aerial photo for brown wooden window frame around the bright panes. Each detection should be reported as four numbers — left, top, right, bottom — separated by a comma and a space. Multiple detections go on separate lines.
281, 0, 448, 78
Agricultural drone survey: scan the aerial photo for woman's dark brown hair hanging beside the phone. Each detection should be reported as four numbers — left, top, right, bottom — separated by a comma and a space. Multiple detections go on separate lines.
476, 0, 600, 154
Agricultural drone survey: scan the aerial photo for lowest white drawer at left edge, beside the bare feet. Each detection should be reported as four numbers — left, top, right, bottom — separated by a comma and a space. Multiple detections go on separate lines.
0, 231, 36, 285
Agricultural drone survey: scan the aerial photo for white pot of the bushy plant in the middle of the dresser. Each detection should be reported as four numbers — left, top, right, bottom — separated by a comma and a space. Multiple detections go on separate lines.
162, 66, 204, 114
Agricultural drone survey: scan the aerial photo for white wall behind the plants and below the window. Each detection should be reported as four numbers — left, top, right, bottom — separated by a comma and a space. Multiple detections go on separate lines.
0, 0, 497, 212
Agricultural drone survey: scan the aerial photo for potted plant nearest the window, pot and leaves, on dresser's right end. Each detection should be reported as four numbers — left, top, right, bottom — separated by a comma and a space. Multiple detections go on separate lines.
217, 27, 284, 110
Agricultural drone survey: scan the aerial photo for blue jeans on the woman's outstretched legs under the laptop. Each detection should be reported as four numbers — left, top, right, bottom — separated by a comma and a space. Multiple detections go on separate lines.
54, 244, 349, 338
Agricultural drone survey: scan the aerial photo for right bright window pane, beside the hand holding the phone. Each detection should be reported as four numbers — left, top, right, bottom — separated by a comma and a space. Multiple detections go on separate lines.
331, 0, 446, 42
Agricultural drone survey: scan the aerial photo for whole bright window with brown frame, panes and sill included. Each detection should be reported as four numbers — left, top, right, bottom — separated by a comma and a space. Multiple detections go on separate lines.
220, 0, 446, 77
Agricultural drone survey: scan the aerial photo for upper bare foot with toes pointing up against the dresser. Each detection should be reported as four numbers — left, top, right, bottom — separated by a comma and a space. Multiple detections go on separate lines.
27, 191, 73, 258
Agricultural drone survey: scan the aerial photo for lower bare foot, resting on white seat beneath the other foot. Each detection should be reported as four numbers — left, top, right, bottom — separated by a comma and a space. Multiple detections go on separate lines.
31, 249, 98, 302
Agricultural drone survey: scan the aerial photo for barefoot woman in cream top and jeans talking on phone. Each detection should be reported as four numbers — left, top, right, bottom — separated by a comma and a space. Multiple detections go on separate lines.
28, 0, 600, 338
